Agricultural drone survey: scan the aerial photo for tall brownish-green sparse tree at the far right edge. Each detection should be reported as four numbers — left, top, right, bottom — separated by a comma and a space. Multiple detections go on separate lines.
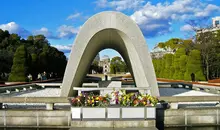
196, 30, 220, 80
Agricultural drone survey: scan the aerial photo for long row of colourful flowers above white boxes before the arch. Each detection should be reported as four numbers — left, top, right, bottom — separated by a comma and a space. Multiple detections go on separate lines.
69, 90, 158, 107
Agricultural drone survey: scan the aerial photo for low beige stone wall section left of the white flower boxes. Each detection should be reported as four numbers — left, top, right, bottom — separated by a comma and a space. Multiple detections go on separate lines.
0, 110, 71, 127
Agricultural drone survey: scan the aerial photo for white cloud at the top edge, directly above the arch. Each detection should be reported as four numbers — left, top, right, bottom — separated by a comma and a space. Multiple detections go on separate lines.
95, 0, 145, 11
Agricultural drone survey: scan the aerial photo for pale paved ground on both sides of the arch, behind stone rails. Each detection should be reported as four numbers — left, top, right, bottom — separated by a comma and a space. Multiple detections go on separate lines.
0, 88, 219, 109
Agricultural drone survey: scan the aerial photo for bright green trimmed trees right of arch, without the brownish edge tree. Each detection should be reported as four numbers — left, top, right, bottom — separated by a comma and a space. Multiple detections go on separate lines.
153, 38, 207, 80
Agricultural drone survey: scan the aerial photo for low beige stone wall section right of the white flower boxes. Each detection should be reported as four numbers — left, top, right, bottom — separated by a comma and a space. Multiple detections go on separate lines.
156, 107, 220, 129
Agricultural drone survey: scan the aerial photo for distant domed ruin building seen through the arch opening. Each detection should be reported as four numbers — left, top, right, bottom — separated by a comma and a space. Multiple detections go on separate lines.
99, 55, 110, 73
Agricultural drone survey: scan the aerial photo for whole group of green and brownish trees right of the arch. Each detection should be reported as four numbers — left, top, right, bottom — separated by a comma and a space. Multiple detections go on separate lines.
153, 30, 220, 81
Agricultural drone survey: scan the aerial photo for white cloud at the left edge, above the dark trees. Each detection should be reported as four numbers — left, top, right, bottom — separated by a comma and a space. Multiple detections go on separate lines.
0, 22, 31, 38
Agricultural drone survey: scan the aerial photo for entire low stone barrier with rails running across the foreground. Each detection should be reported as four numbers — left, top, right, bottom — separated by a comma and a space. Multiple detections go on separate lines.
0, 96, 220, 128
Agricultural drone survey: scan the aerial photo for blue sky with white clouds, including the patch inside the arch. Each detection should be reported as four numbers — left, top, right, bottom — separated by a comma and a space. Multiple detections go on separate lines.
0, 0, 220, 57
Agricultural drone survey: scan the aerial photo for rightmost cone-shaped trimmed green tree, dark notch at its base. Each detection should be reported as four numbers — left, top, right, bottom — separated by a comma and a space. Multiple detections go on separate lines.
184, 50, 206, 81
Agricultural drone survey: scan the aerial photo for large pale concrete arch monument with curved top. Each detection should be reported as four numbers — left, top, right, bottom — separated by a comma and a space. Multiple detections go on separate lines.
61, 11, 159, 97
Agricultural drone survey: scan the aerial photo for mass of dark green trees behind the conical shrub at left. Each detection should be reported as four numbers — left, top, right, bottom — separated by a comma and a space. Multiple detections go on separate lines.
0, 29, 67, 80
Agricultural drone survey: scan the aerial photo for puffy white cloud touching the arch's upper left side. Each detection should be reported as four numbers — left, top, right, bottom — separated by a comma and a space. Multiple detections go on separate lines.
57, 25, 80, 38
